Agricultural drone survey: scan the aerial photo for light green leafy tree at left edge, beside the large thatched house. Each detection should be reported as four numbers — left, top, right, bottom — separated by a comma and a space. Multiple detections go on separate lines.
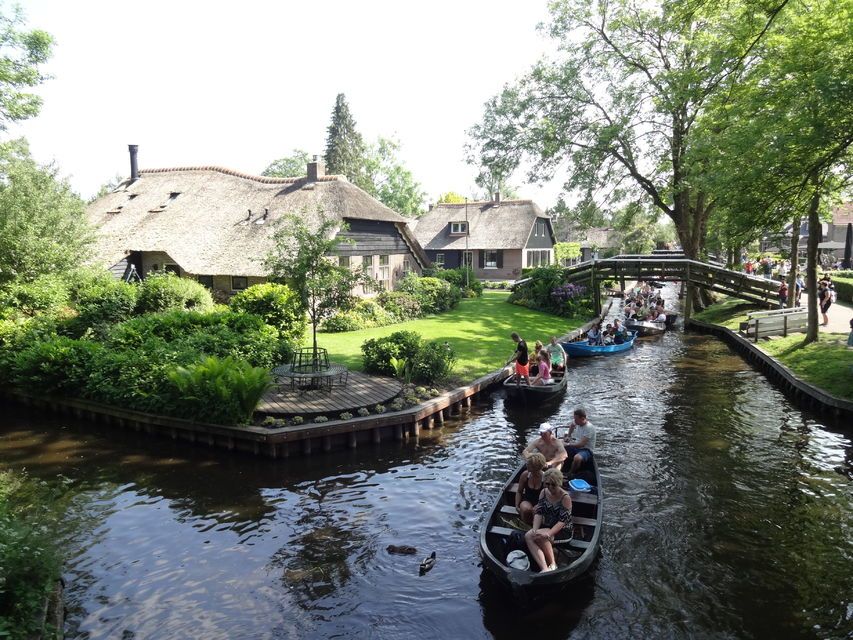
0, 140, 91, 284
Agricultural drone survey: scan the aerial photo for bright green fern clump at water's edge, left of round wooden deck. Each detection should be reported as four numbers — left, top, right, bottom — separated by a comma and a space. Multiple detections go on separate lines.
168, 357, 272, 424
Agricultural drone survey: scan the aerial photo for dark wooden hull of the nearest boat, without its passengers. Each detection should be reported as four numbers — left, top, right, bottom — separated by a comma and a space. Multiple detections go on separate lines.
480, 457, 603, 603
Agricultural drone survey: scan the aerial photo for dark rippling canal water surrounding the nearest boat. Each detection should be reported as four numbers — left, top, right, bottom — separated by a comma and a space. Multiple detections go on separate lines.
0, 292, 853, 640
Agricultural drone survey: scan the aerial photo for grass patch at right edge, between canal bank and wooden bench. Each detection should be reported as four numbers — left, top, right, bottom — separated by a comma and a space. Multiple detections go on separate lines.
758, 333, 853, 400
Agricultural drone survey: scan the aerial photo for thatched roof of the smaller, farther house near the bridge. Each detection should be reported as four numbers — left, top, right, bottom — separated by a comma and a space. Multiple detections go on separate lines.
415, 200, 554, 250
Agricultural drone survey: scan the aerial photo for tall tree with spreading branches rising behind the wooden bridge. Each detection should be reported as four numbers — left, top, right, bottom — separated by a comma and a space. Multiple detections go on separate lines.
471, 0, 788, 308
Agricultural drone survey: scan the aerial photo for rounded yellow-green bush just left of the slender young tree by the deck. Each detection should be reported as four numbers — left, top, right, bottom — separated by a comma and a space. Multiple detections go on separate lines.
229, 282, 306, 344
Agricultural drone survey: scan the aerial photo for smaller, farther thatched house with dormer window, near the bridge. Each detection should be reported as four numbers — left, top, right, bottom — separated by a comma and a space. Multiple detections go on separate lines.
415, 195, 555, 280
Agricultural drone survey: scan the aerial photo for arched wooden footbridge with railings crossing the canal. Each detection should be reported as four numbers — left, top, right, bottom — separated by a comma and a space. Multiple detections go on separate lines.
565, 254, 779, 314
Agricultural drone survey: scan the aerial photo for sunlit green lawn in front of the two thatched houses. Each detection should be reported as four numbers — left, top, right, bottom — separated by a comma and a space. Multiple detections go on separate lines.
308, 290, 590, 381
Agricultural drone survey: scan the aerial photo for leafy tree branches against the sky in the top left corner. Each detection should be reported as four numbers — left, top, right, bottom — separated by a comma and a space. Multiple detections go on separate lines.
0, 7, 53, 130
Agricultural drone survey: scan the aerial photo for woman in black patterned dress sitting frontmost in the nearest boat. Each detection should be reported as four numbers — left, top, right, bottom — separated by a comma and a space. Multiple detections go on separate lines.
524, 469, 573, 572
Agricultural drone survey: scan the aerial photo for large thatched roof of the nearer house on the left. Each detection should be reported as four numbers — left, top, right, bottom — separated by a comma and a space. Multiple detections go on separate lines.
87, 166, 429, 276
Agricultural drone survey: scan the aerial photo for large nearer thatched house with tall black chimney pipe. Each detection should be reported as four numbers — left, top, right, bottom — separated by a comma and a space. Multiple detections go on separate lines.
87, 150, 428, 292
